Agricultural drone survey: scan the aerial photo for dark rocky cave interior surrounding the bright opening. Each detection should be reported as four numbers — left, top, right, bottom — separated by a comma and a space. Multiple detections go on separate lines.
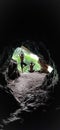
0, 1, 60, 130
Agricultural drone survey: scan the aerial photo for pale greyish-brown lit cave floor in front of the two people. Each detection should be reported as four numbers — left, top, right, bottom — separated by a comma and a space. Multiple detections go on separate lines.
8, 72, 47, 103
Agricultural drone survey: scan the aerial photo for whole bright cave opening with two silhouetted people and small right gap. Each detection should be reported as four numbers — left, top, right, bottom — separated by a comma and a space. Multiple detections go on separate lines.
12, 45, 53, 73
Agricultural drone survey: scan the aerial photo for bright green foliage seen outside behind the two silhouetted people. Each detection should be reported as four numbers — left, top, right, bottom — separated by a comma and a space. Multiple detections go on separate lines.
12, 48, 41, 72
